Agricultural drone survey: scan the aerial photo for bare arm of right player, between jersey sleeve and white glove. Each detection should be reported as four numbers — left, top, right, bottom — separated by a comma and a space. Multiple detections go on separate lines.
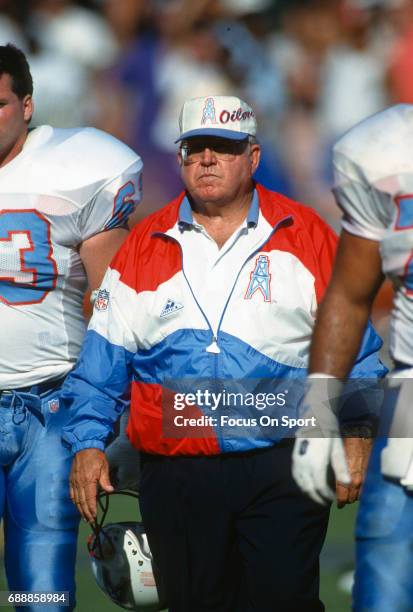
309, 230, 383, 378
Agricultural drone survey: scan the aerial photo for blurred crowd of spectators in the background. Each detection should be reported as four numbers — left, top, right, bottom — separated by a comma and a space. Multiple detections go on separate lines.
0, 0, 413, 334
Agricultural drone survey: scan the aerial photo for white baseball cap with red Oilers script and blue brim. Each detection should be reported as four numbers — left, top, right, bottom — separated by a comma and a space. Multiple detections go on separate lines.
175, 96, 257, 142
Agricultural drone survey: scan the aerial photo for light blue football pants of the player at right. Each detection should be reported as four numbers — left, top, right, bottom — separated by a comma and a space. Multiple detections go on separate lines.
353, 438, 413, 612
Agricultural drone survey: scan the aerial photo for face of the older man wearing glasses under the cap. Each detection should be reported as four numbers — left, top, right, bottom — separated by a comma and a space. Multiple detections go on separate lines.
178, 136, 260, 204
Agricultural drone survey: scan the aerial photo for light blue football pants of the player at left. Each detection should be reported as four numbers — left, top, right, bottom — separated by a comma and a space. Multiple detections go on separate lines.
0, 387, 79, 612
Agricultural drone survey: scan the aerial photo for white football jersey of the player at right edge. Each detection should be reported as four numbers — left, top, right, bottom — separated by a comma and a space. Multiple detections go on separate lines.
333, 104, 413, 365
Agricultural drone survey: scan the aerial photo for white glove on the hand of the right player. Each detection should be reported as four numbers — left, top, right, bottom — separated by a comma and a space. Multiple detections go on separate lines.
292, 374, 351, 504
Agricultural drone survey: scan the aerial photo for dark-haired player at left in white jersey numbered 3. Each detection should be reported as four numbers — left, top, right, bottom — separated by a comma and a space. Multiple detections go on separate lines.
0, 45, 142, 611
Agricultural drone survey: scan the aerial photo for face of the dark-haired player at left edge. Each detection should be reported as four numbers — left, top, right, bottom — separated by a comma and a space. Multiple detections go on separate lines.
0, 73, 33, 166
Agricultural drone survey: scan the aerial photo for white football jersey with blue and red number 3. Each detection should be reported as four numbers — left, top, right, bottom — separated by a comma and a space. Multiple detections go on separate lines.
0, 126, 142, 389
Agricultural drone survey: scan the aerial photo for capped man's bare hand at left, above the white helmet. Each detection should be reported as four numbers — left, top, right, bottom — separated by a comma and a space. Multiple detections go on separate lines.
70, 448, 114, 523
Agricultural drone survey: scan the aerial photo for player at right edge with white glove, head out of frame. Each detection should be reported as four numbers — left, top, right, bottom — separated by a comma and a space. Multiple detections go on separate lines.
293, 104, 413, 612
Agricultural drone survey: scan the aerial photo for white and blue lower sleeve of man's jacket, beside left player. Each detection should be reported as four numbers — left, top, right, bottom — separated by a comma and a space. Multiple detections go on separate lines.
62, 268, 136, 453
